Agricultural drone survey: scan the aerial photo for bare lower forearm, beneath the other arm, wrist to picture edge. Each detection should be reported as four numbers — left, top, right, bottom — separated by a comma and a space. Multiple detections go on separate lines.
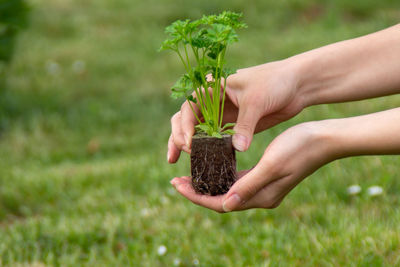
317, 108, 400, 159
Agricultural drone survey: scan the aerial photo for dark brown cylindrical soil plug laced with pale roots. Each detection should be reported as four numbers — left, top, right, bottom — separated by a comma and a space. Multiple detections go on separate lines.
190, 134, 237, 196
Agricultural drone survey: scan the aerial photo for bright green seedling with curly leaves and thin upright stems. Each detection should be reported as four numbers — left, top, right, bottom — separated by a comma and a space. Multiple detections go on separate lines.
160, 11, 247, 138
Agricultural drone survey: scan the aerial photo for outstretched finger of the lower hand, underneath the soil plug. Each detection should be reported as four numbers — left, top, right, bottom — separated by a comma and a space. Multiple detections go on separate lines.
171, 177, 224, 212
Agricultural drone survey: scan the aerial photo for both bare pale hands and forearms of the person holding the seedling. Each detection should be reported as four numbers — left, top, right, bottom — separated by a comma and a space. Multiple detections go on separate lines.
168, 24, 400, 212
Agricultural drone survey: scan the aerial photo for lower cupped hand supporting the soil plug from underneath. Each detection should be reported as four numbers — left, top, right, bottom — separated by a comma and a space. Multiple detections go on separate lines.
171, 122, 339, 212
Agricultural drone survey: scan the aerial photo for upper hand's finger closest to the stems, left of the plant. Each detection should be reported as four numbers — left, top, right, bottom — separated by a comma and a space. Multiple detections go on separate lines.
181, 101, 200, 148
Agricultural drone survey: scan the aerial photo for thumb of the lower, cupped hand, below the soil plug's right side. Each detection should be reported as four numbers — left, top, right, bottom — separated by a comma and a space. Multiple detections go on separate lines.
222, 165, 270, 212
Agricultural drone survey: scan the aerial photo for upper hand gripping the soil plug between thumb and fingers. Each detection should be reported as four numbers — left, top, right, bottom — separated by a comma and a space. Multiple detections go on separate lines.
168, 59, 305, 163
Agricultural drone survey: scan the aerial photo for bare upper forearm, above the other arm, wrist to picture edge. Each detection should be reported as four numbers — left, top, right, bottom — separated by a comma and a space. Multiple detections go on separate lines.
288, 24, 400, 106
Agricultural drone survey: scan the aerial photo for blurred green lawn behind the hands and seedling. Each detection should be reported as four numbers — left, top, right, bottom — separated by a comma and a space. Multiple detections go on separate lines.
0, 0, 400, 266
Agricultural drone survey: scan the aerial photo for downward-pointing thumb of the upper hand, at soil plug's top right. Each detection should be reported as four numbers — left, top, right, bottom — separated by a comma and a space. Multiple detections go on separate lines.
232, 106, 261, 152
